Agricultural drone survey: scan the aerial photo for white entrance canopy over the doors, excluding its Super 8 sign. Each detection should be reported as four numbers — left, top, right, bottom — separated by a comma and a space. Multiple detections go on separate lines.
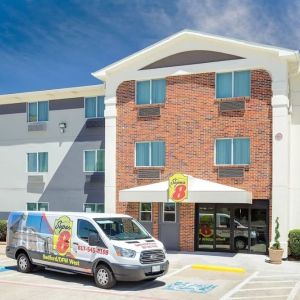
119, 176, 252, 204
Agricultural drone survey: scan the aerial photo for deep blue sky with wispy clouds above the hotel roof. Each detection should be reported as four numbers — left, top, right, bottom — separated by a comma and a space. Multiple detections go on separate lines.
0, 0, 300, 94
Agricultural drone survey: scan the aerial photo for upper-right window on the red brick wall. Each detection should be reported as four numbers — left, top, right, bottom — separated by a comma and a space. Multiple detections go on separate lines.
216, 71, 251, 98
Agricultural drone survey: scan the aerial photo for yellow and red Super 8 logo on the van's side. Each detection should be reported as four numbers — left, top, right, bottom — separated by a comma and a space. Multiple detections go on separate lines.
53, 216, 73, 256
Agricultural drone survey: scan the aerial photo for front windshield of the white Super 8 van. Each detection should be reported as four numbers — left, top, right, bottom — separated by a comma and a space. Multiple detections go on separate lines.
94, 218, 151, 241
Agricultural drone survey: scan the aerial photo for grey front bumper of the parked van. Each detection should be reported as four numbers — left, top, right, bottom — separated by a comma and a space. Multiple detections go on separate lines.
111, 260, 169, 281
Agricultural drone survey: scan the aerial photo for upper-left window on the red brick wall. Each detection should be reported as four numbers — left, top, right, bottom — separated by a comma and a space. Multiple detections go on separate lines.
136, 79, 166, 105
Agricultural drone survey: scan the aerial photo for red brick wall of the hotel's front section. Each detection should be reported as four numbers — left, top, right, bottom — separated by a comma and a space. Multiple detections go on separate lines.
116, 70, 272, 251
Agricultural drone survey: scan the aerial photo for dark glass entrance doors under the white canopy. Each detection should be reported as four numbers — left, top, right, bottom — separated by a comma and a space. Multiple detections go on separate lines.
195, 200, 269, 253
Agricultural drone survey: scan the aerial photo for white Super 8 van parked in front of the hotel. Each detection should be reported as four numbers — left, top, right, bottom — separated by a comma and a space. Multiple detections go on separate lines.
6, 211, 169, 289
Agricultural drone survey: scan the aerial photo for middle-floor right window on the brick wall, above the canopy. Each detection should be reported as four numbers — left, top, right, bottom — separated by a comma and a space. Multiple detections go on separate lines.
215, 138, 250, 165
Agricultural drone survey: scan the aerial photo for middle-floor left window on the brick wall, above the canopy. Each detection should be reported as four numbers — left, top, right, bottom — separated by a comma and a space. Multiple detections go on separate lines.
135, 141, 165, 167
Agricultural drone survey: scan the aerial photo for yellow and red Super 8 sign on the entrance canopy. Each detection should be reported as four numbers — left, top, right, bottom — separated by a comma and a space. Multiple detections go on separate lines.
168, 173, 188, 202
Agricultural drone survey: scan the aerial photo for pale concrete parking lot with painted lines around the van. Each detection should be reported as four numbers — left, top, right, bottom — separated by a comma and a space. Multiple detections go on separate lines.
0, 246, 300, 300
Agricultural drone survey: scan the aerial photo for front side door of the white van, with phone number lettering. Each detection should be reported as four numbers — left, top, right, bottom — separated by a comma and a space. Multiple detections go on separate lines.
72, 218, 106, 272
